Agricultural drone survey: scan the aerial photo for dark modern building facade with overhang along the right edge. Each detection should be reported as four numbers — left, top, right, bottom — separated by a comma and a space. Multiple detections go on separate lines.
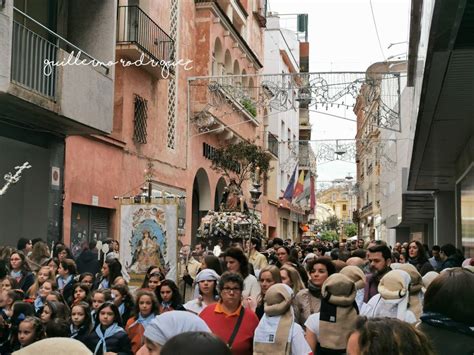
403, 0, 474, 257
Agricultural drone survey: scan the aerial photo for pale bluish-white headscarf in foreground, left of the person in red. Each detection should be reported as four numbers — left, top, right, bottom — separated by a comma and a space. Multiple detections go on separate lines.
144, 311, 211, 345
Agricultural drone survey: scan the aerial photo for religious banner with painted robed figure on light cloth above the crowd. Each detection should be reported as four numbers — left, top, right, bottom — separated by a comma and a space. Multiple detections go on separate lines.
120, 203, 178, 281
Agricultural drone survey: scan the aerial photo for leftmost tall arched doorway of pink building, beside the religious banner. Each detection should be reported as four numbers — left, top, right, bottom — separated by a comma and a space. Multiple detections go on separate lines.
191, 168, 211, 245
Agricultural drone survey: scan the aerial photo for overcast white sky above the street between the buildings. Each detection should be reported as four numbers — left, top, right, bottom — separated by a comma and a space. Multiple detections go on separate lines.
268, 0, 410, 188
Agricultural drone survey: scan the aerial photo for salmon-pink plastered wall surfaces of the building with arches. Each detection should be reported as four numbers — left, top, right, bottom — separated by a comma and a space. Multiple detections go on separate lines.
63, 0, 274, 249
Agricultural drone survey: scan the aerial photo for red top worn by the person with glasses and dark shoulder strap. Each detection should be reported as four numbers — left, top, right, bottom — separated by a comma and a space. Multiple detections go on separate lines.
199, 303, 258, 355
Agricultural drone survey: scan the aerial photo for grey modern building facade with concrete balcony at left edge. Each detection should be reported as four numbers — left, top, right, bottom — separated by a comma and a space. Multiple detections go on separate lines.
0, 0, 116, 245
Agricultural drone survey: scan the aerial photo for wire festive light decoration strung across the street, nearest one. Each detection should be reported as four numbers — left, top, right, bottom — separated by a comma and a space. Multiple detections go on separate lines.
188, 72, 401, 132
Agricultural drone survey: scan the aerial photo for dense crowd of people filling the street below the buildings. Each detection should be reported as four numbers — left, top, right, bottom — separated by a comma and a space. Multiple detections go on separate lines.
0, 238, 474, 355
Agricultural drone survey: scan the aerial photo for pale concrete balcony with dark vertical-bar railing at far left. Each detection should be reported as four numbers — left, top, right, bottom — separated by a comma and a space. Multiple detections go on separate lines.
0, 5, 114, 135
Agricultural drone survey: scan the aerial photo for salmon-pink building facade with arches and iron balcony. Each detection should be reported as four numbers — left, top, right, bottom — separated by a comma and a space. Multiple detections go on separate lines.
63, 0, 264, 252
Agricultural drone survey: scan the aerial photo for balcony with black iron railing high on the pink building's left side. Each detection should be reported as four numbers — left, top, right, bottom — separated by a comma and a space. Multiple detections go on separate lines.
117, 5, 174, 79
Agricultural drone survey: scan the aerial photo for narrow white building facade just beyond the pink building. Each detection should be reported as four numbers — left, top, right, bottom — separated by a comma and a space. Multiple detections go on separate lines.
263, 13, 305, 240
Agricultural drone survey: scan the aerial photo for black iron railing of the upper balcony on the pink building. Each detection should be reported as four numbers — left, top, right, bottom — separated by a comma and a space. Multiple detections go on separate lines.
117, 5, 174, 63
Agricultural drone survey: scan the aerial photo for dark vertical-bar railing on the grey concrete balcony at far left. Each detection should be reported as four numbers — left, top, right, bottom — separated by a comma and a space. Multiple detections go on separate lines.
11, 21, 57, 98
